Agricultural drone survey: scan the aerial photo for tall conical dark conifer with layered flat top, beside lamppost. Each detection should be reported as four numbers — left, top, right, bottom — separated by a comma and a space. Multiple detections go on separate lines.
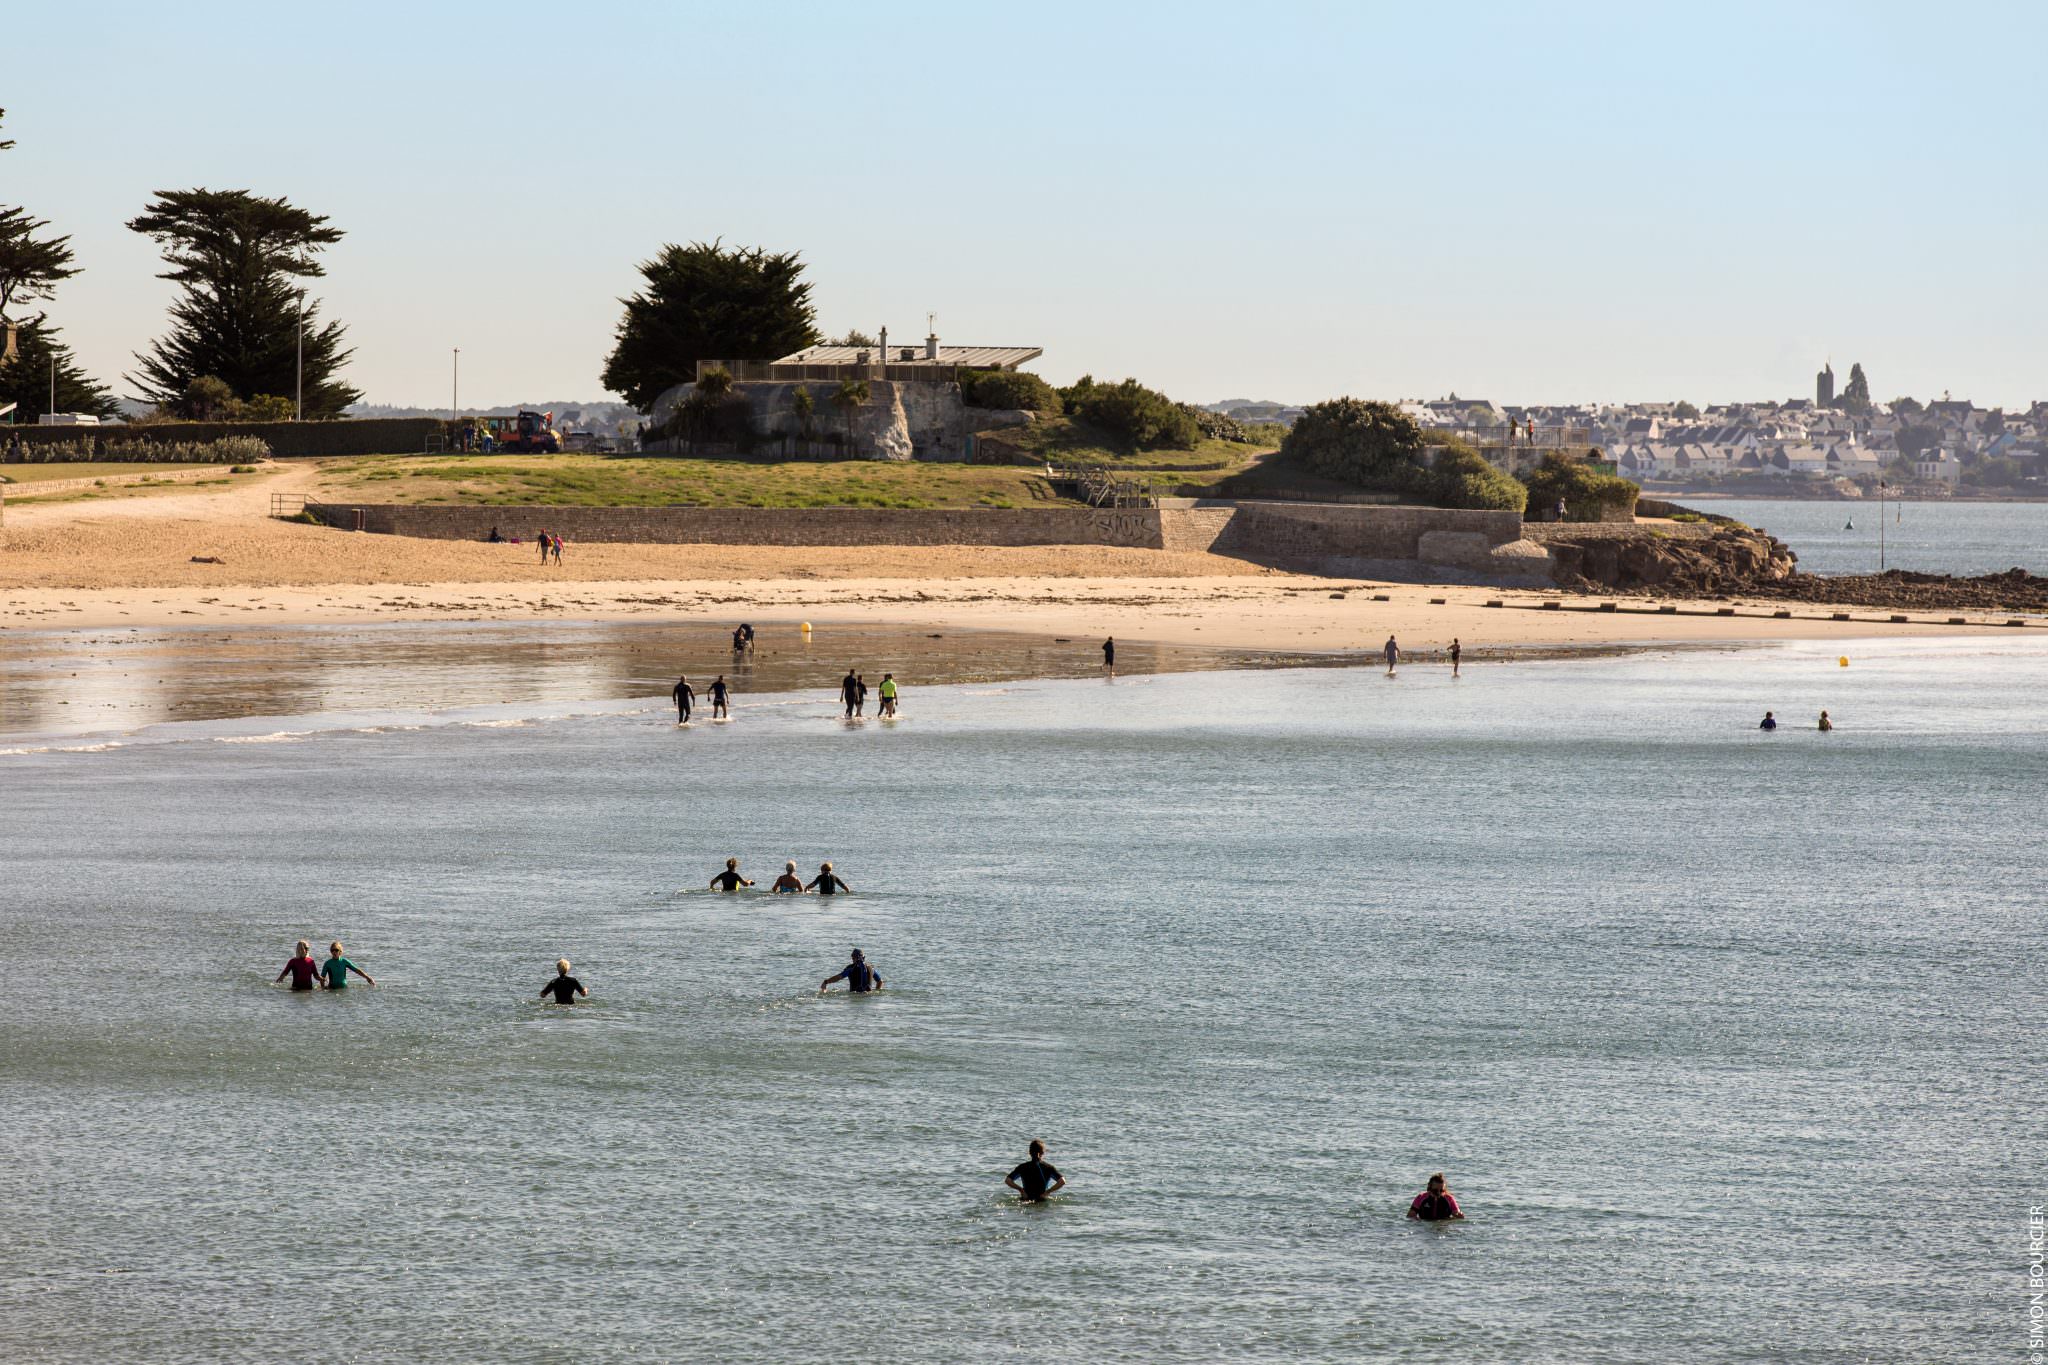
129, 188, 362, 417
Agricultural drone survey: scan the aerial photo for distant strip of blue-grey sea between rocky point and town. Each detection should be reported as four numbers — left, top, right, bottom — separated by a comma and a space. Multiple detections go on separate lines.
1703, 497, 2048, 575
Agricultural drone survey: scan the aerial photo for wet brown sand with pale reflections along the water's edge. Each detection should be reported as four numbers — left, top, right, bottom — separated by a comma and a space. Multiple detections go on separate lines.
0, 622, 1341, 739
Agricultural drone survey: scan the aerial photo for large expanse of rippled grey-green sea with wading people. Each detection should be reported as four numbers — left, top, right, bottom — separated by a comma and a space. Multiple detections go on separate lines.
0, 641, 2048, 1363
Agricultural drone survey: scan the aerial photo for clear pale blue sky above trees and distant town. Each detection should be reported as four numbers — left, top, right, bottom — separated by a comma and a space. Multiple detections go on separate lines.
0, 0, 2048, 407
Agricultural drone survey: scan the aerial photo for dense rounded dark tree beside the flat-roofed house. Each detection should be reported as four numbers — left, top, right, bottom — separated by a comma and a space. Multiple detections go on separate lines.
604, 241, 817, 411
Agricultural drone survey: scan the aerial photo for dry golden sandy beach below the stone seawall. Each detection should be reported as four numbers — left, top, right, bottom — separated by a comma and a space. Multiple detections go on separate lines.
0, 465, 2009, 651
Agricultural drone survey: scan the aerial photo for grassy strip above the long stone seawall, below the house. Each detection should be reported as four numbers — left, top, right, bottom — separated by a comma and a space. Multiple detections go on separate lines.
313, 454, 1065, 508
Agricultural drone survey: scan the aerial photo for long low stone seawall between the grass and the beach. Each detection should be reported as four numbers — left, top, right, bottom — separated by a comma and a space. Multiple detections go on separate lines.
305, 503, 1522, 567
